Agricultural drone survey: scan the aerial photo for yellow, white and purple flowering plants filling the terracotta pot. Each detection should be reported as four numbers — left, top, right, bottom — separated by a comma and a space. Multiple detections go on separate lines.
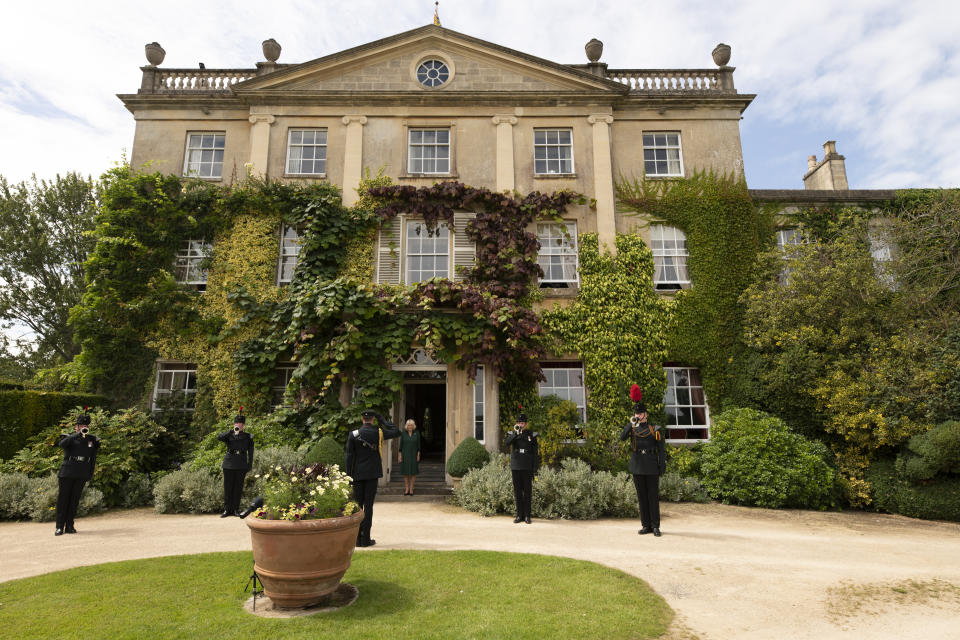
254, 463, 360, 520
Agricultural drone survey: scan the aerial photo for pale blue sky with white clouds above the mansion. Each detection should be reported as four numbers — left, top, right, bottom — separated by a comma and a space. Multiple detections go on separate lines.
0, 0, 960, 189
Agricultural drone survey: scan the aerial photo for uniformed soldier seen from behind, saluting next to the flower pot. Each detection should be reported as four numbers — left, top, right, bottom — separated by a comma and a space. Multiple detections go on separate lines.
347, 409, 400, 547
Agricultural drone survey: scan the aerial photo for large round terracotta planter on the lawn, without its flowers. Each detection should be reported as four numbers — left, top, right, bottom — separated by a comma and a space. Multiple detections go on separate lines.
244, 511, 363, 608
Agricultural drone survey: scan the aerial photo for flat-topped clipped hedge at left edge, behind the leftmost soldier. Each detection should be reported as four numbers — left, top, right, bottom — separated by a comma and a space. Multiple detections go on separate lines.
0, 388, 109, 460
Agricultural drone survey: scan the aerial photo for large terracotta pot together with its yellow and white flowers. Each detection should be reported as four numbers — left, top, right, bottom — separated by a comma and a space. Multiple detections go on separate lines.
245, 463, 363, 608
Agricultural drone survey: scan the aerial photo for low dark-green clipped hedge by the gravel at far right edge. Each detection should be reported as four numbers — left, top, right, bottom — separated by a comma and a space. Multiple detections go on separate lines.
866, 460, 960, 522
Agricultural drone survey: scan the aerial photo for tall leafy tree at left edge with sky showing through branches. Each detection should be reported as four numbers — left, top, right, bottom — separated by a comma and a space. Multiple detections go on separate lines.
0, 173, 98, 373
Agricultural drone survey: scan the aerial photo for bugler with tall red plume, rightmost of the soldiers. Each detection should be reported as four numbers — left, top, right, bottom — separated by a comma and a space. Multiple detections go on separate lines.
620, 385, 667, 538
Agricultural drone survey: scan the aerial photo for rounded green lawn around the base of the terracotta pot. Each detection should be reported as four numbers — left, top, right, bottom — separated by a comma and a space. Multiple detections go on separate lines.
0, 551, 673, 640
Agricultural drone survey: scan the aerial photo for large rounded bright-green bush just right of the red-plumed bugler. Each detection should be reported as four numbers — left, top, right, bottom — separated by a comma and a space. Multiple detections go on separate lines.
701, 409, 836, 509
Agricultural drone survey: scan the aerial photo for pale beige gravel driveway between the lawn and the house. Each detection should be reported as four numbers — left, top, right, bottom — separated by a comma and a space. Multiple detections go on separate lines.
0, 502, 960, 640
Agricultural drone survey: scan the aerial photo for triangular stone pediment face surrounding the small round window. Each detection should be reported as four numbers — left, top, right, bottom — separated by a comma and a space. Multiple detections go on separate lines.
234, 25, 624, 95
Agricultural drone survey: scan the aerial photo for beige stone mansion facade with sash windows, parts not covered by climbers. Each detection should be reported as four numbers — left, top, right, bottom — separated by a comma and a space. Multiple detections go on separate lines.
119, 25, 892, 468
